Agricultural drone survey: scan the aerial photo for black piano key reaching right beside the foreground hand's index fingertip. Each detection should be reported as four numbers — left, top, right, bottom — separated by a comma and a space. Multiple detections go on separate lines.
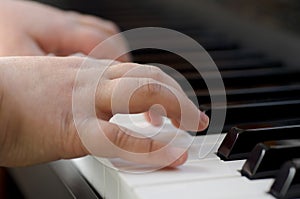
200, 100, 300, 133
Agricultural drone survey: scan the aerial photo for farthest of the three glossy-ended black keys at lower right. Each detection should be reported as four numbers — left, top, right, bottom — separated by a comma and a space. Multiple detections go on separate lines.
217, 123, 300, 160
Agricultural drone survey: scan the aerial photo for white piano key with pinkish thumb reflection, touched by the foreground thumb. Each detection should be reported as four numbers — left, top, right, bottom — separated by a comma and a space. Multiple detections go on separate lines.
111, 158, 244, 187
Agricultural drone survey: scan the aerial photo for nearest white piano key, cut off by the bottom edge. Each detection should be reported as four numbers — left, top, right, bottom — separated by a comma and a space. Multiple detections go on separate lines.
132, 177, 274, 199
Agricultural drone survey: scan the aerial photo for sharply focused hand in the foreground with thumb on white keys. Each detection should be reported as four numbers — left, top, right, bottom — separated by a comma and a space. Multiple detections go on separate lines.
0, 57, 208, 166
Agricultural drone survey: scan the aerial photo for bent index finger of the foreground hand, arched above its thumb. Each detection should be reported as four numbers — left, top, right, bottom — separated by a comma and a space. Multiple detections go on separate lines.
100, 78, 209, 131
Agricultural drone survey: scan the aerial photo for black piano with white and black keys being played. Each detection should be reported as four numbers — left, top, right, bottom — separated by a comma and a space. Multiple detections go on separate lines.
10, 0, 300, 199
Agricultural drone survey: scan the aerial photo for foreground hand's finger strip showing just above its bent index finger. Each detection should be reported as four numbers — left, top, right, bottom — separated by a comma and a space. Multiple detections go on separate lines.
106, 63, 184, 93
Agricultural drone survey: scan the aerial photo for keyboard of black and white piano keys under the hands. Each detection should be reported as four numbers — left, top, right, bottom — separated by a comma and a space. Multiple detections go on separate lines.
73, 0, 300, 199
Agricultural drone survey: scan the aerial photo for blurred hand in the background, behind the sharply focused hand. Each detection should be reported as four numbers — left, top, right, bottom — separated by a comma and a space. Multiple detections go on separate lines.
0, 0, 129, 61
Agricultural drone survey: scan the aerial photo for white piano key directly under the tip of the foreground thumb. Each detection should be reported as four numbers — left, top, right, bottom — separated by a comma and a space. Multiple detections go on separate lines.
115, 160, 244, 188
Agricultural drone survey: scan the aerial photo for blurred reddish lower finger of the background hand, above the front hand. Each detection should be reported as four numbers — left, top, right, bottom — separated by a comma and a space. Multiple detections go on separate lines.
35, 23, 130, 62
